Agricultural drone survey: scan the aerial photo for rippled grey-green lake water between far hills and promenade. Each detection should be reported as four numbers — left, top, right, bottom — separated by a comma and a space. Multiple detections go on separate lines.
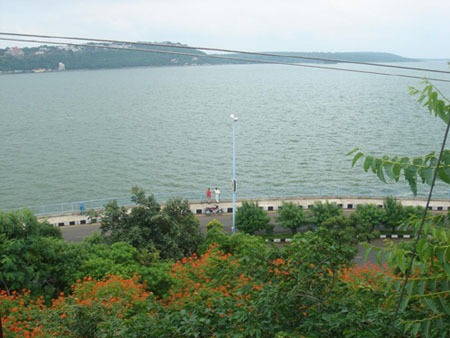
0, 62, 450, 209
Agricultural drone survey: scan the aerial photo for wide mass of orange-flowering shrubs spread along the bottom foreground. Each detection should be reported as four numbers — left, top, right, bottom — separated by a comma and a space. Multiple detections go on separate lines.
0, 236, 448, 337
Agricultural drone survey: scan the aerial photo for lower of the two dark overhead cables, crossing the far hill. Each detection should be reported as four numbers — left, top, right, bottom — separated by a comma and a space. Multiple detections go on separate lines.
0, 38, 450, 83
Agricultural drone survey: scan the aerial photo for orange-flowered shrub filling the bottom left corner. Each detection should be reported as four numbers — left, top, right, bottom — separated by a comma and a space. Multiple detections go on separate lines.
0, 276, 151, 337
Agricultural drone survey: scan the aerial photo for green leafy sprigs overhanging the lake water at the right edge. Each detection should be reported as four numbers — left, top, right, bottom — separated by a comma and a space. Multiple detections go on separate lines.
347, 81, 450, 195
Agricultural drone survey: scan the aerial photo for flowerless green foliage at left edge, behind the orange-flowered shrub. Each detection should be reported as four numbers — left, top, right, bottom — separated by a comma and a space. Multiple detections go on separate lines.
0, 210, 172, 300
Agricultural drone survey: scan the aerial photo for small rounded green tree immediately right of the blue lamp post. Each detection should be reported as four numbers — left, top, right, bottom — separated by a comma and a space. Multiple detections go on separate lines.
236, 201, 273, 235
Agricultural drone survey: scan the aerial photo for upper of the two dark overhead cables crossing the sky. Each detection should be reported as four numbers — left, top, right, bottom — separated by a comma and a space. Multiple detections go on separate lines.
0, 32, 450, 74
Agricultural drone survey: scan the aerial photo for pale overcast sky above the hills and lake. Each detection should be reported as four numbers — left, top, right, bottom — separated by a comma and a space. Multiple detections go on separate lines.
0, 0, 450, 58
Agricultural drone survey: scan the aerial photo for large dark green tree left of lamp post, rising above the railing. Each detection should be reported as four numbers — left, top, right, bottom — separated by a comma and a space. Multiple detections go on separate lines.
101, 187, 203, 259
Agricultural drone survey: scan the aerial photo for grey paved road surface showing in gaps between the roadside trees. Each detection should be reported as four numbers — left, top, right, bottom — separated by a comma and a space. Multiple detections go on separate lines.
61, 211, 400, 266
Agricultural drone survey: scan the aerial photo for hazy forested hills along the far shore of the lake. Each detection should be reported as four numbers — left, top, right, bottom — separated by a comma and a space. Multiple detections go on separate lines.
0, 42, 414, 72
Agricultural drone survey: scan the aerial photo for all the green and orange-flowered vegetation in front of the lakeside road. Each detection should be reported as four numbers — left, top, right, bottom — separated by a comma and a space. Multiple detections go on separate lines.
0, 84, 450, 338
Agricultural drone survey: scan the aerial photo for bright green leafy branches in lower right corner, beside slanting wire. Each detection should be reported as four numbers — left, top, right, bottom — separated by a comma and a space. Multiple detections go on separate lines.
363, 215, 450, 337
